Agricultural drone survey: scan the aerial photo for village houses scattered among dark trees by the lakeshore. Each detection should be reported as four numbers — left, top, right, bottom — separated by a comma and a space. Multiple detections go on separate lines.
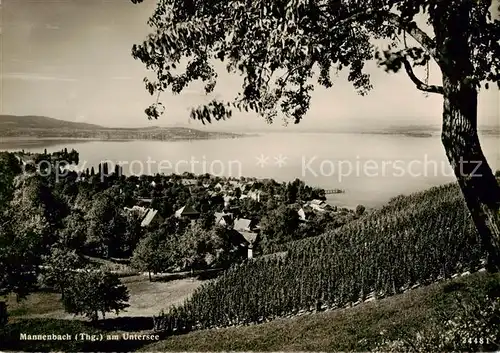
9, 149, 365, 273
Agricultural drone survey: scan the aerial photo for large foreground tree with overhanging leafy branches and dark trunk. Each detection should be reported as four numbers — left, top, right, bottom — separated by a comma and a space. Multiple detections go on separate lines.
131, 0, 500, 270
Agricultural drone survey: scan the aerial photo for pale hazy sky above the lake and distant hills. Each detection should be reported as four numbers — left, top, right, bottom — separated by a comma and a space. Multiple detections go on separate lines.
0, 0, 500, 131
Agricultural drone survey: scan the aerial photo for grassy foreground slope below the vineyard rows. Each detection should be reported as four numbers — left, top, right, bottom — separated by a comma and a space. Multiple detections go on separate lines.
141, 273, 500, 352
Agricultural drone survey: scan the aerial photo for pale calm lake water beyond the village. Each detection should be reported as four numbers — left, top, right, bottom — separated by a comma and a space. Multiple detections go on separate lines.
0, 133, 500, 207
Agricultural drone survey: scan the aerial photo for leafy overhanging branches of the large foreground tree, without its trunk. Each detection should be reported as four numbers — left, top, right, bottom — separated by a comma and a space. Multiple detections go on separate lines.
132, 0, 500, 123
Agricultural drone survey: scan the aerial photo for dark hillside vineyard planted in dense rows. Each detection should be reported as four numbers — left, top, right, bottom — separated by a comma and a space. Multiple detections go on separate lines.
147, 184, 485, 332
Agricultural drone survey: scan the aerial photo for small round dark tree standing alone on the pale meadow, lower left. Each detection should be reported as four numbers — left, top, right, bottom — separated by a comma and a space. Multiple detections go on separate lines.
62, 270, 129, 321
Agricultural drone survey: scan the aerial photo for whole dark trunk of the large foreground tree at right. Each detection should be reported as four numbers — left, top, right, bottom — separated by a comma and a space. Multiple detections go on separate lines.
433, 0, 500, 271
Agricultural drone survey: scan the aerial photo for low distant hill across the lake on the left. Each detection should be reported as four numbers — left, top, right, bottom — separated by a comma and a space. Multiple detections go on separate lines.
0, 115, 243, 140
